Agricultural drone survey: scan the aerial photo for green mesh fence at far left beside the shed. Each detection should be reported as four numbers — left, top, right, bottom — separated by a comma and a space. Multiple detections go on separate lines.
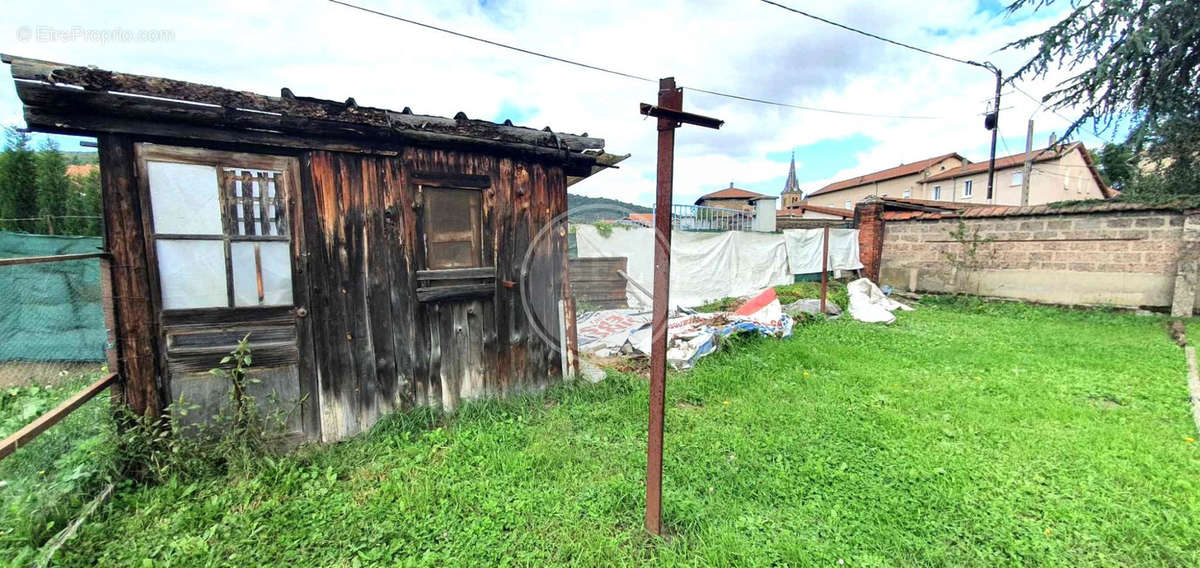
0, 232, 107, 362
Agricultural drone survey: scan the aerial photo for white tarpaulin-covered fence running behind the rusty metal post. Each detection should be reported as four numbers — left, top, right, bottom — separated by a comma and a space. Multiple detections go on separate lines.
575, 225, 863, 306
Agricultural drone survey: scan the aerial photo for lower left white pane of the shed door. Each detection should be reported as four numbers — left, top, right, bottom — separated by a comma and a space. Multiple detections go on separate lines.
155, 239, 229, 310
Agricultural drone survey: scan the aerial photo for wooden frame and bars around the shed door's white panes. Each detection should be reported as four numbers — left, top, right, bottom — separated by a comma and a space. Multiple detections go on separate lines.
136, 143, 298, 312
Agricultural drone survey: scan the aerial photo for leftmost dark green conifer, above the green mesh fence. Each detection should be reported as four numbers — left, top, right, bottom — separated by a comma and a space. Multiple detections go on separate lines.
0, 127, 38, 233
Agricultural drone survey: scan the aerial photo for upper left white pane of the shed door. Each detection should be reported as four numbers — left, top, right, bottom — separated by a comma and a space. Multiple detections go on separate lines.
146, 162, 222, 234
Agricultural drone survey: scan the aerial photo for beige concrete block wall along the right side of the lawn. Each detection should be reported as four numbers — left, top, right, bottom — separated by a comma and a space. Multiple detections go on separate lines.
878, 211, 1195, 307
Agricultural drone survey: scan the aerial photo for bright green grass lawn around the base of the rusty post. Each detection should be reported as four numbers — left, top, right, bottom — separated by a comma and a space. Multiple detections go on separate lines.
37, 299, 1200, 567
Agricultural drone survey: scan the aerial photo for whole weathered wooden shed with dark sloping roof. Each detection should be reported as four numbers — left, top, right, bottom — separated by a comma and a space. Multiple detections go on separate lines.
2, 55, 624, 441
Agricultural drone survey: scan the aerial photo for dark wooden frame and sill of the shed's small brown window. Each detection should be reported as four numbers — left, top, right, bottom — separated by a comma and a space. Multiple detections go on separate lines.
409, 172, 496, 301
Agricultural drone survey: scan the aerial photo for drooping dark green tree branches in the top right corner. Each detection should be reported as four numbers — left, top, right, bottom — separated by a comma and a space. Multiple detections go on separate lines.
1007, 0, 1200, 195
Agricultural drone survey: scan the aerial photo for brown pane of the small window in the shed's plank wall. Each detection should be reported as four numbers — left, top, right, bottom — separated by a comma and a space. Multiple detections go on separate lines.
422, 187, 482, 270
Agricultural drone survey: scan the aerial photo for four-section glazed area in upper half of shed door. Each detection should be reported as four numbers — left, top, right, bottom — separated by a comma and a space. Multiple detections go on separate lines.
145, 160, 292, 310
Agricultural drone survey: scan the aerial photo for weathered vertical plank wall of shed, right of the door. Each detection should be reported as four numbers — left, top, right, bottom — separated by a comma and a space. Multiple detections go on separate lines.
301, 149, 566, 441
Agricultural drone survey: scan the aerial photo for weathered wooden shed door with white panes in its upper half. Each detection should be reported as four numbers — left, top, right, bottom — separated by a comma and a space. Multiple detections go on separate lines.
138, 144, 316, 436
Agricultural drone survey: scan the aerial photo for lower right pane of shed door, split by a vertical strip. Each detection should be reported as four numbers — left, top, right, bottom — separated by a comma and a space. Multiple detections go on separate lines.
229, 241, 292, 306
